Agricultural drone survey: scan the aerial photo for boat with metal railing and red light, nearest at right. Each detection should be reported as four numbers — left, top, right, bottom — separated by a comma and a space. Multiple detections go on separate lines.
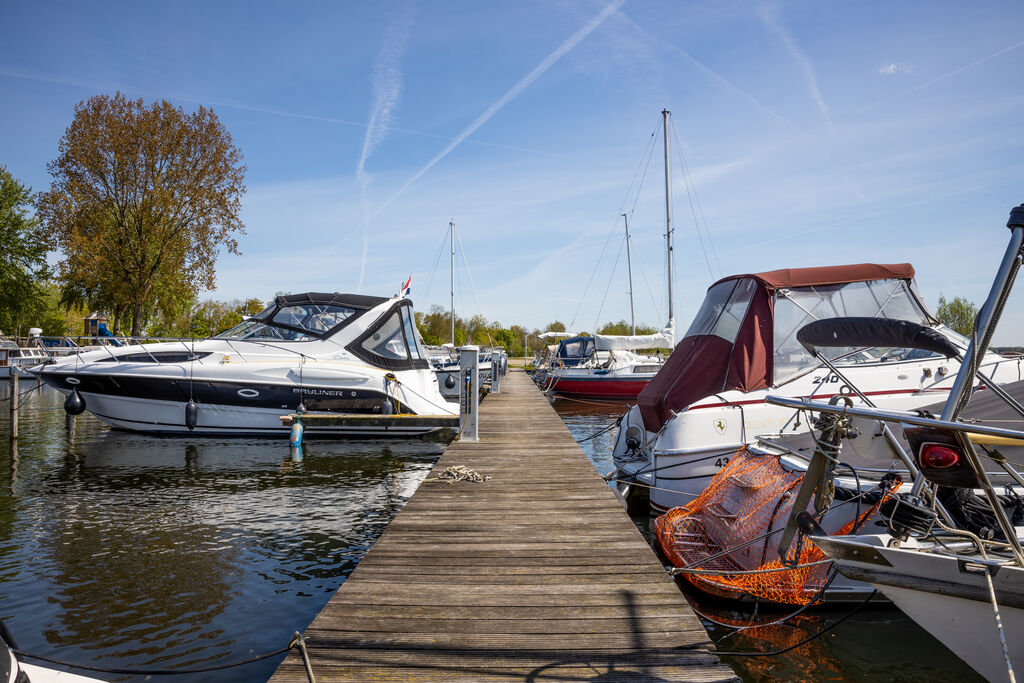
737, 200, 1024, 681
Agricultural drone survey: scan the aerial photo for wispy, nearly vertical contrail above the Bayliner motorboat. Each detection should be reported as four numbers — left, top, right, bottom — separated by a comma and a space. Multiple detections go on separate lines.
355, 0, 414, 292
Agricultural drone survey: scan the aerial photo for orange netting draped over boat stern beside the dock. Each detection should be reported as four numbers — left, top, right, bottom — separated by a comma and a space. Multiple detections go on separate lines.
654, 447, 884, 604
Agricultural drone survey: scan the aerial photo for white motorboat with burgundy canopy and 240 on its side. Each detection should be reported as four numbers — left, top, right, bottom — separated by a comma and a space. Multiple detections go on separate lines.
614, 263, 1022, 514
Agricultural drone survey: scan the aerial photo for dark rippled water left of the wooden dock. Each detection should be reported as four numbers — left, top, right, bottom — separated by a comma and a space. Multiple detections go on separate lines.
0, 382, 443, 681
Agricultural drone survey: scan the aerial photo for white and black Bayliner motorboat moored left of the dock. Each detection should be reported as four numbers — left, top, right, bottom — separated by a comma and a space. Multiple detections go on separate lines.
33, 293, 458, 436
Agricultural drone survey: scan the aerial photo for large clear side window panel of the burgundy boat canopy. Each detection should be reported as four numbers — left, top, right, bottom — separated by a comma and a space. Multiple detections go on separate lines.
773, 280, 931, 385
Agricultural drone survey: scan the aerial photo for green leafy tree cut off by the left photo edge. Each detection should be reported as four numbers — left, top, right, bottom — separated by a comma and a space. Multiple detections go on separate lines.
0, 166, 49, 334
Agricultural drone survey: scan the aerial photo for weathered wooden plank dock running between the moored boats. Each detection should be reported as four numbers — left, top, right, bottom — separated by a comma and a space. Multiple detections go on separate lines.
271, 371, 738, 681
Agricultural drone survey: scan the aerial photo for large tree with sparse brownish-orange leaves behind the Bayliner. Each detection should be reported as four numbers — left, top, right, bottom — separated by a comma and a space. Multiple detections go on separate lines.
37, 92, 246, 336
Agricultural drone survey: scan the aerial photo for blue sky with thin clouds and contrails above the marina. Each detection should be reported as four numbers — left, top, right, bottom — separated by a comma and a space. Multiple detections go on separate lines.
6, 0, 1024, 344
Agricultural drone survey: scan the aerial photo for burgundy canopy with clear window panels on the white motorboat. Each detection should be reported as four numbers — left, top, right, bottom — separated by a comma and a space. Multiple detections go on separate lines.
637, 263, 935, 431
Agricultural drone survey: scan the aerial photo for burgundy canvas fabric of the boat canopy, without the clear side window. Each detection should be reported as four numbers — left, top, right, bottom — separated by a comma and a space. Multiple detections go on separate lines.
637, 263, 913, 431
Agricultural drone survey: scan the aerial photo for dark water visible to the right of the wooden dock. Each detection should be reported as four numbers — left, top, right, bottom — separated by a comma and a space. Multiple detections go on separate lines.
554, 399, 982, 682
